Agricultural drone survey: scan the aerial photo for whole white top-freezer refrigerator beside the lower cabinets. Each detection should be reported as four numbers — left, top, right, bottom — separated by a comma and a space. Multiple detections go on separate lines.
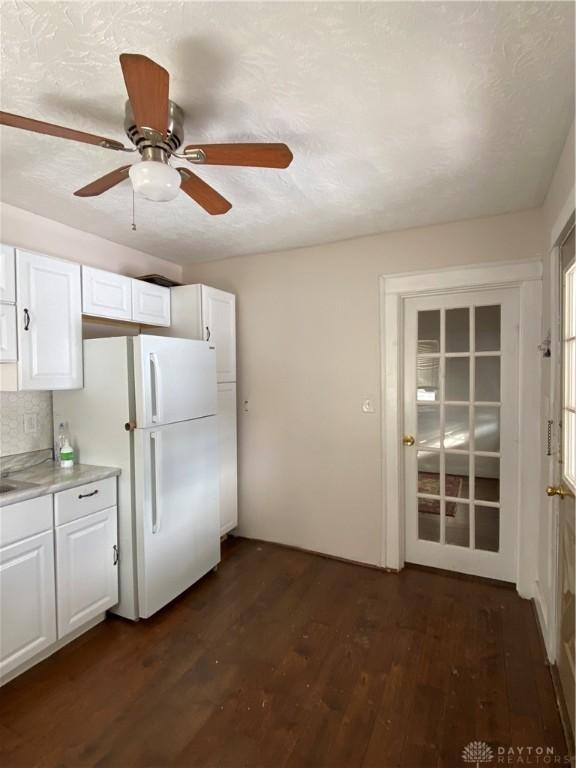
54, 335, 220, 619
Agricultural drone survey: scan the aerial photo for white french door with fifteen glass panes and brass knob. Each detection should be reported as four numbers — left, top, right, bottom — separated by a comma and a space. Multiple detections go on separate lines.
404, 287, 518, 581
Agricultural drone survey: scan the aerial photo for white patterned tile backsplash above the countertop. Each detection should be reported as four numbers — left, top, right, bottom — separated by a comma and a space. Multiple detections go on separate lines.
0, 392, 53, 456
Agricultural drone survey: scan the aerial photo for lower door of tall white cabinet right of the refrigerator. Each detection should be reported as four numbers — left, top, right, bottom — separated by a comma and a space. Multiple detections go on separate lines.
218, 384, 238, 536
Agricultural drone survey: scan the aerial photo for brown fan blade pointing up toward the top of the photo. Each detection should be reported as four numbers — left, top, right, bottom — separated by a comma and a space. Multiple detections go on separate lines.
120, 53, 170, 136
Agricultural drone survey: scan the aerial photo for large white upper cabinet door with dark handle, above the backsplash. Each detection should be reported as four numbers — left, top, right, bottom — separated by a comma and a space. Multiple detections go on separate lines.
16, 251, 82, 390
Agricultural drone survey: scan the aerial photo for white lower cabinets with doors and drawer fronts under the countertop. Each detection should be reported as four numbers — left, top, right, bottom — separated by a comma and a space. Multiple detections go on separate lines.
0, 477, 119, 684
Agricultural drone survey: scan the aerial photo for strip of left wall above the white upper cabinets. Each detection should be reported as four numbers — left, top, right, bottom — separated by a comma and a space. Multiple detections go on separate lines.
0, 202, 182, 281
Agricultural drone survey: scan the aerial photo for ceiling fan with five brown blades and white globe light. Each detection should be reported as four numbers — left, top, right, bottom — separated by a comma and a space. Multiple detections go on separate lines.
0, 53, 292, 214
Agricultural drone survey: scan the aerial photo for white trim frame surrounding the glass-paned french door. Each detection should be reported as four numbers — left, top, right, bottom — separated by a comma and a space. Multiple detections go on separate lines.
380, 259, 543, 597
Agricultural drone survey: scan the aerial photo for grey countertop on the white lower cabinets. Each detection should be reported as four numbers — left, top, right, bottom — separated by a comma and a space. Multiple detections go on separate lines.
0, 461, 120, 507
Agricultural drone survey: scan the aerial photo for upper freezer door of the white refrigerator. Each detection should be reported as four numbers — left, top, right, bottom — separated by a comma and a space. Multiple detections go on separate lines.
133, 335, 217, 428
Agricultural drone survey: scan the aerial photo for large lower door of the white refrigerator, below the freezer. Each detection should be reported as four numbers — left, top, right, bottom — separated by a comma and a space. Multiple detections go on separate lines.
134, 416, 220, 618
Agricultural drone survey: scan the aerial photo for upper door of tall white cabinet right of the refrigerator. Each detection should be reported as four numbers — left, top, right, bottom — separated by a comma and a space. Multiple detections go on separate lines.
202, 285, 236, 382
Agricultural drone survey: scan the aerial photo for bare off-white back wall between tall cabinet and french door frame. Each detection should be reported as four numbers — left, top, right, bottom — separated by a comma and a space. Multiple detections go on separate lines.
184, 209, 547, 564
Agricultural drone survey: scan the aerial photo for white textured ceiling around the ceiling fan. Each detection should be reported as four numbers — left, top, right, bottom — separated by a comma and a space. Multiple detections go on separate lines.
0, 1, 574, 263
